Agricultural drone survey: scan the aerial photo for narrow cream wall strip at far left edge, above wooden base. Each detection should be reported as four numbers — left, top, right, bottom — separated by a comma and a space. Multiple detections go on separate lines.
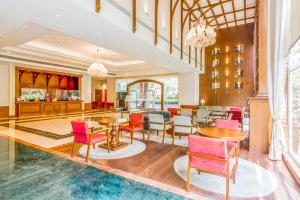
0, 63, 9, 106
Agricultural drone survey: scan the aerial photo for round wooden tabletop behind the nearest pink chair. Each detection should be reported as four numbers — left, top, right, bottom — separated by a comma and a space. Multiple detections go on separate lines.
199, 127, 246, 142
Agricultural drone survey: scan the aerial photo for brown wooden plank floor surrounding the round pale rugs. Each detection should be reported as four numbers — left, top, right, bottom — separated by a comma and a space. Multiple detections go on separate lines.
53, 137, 300, 200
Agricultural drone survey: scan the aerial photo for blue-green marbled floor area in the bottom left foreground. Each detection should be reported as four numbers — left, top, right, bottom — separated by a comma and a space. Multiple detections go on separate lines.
0, 138, 185, 200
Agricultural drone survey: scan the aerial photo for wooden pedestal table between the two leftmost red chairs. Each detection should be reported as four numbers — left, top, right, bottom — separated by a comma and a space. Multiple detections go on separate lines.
98, 117, 128, 151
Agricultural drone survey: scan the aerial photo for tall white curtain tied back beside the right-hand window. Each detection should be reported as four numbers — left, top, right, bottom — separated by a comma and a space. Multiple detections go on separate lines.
268, 0, 290, 160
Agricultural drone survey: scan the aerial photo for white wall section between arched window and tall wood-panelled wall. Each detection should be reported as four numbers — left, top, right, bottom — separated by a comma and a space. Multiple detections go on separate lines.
179, 72, 200, 105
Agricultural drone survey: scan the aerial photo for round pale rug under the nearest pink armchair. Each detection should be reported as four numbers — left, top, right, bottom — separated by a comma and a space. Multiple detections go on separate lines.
174, 156, 277, 198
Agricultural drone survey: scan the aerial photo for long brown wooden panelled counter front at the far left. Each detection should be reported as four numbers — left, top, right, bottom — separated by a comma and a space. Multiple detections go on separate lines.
16, 101, 82, 117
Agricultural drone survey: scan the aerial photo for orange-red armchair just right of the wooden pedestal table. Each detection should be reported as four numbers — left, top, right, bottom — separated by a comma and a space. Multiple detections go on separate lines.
119, 113, 145, 144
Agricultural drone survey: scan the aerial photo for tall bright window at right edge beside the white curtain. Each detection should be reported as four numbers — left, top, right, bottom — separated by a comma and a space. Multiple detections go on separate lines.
288, 40, 300, 166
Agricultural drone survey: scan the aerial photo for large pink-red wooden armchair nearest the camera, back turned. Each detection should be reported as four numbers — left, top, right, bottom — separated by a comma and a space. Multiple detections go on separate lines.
186, 135, 237, 200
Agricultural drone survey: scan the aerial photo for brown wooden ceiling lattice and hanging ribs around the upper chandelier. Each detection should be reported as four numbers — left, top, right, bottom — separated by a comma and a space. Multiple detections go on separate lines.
96, 0, 257, 67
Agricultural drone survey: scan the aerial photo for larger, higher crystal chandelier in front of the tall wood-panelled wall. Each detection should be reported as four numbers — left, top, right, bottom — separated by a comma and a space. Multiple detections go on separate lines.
186, 19, 216, 48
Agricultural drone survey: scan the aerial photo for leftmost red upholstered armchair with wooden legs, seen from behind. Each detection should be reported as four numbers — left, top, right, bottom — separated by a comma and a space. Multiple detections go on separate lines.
71, 121, 110, 161
